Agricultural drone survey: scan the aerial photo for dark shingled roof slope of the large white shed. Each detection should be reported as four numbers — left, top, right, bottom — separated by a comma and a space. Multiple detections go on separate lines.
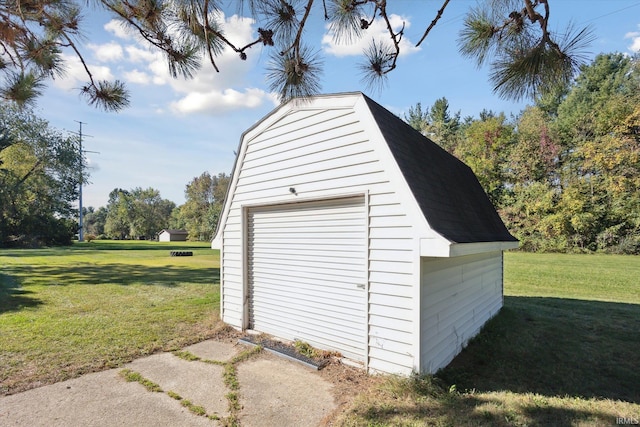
364, 96, 517, 243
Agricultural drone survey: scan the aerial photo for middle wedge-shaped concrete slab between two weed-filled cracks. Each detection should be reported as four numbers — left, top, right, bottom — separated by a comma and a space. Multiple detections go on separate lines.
125, 353, 228, 417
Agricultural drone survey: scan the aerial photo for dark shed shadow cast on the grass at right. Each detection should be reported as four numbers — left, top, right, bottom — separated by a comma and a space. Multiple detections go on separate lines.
436, 297, 640, 403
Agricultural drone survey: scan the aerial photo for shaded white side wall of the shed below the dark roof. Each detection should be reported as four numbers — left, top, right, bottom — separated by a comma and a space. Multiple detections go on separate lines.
420, 252, 502, 373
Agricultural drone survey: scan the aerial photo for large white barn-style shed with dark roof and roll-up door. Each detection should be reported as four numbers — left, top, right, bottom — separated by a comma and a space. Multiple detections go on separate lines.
212, 93, 518, 374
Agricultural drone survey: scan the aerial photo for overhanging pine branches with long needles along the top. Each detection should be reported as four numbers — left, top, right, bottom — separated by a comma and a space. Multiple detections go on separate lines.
0, 0, 590, 111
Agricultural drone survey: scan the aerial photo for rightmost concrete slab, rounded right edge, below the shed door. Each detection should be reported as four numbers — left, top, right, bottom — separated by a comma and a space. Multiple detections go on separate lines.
238, 354, 336, 427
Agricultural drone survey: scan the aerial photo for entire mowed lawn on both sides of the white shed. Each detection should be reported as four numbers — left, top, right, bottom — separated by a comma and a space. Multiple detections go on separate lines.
0, 247, 640, 426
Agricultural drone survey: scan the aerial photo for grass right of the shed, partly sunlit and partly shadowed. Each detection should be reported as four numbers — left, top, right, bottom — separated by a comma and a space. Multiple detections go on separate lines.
339, 252, 640, 426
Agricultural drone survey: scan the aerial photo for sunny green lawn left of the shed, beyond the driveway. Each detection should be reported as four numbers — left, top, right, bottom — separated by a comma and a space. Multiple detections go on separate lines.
0, 241, 219, 394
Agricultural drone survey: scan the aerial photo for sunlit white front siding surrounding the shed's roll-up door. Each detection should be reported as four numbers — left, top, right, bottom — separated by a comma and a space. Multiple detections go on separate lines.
221, 103, 419, 373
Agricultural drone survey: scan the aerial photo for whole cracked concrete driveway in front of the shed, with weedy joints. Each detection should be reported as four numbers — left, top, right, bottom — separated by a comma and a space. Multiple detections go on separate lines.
0, 340, 337, 427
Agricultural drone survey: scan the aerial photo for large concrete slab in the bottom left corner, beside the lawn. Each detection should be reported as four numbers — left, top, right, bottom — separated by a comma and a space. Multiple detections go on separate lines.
0, 369, 212, 427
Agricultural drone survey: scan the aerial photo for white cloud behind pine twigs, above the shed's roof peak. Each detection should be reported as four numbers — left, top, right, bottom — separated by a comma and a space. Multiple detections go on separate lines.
322, 14, 420, 57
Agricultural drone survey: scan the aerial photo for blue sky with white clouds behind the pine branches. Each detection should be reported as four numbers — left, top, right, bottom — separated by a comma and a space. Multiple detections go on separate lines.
32, 0, 640, 208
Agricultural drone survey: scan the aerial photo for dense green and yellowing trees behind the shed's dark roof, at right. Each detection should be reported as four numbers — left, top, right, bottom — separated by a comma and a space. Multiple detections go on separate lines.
405, 54, 640, 254
